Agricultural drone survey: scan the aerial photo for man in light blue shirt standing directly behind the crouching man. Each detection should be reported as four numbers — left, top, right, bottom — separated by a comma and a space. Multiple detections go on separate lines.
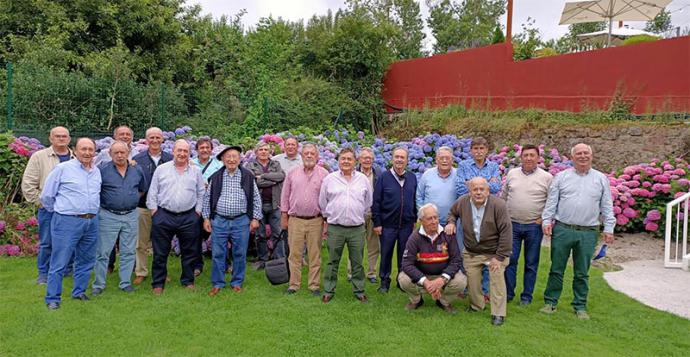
416, 146, 458, 226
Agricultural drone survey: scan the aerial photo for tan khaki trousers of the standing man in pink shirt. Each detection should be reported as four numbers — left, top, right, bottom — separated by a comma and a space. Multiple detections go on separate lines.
288, 217, 323, 291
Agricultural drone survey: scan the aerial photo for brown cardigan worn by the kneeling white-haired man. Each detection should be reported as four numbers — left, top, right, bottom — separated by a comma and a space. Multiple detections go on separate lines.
447, 195, 513, 261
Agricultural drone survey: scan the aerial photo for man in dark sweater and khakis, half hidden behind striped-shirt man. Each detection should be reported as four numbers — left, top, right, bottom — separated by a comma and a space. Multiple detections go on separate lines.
132, 127, 173, 285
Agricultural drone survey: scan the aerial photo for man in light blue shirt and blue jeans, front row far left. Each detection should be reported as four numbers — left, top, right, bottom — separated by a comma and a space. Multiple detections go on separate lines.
40, 138, 101, 310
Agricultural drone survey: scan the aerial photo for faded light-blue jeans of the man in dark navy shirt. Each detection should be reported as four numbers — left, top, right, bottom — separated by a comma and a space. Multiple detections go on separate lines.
91, 208, 139, 289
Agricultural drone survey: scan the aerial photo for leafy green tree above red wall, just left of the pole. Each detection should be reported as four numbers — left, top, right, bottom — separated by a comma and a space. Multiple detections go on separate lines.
427, 0, 506, 53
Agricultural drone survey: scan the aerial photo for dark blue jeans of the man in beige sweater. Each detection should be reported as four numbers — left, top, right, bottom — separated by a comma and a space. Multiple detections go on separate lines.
505, 222, 543, 302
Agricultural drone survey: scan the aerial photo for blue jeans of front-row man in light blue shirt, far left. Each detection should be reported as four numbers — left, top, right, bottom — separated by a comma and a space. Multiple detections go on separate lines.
45, 213, 98, 304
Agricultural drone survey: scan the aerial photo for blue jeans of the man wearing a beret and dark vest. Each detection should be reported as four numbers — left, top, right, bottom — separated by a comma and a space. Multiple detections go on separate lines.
211, 215, 249, 288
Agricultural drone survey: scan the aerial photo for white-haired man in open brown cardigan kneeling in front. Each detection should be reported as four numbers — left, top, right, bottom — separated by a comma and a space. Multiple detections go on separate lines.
446, 177, 513, 326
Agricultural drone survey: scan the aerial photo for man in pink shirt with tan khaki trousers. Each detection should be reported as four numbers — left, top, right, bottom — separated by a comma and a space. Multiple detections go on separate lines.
280, 143, 328, 296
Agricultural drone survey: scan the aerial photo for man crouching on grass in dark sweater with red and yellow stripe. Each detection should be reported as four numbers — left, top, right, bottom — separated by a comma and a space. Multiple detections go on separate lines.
398, 203, 467, 313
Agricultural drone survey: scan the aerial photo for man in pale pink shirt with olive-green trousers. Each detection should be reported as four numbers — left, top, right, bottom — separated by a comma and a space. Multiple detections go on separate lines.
319, 148, 373, 303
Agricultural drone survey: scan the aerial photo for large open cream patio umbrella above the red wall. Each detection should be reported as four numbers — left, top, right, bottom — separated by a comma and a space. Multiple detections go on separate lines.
558, 0, 672, 46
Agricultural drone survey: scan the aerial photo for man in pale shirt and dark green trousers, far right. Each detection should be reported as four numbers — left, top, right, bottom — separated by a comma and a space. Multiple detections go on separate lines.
539, 144, 616, 320
